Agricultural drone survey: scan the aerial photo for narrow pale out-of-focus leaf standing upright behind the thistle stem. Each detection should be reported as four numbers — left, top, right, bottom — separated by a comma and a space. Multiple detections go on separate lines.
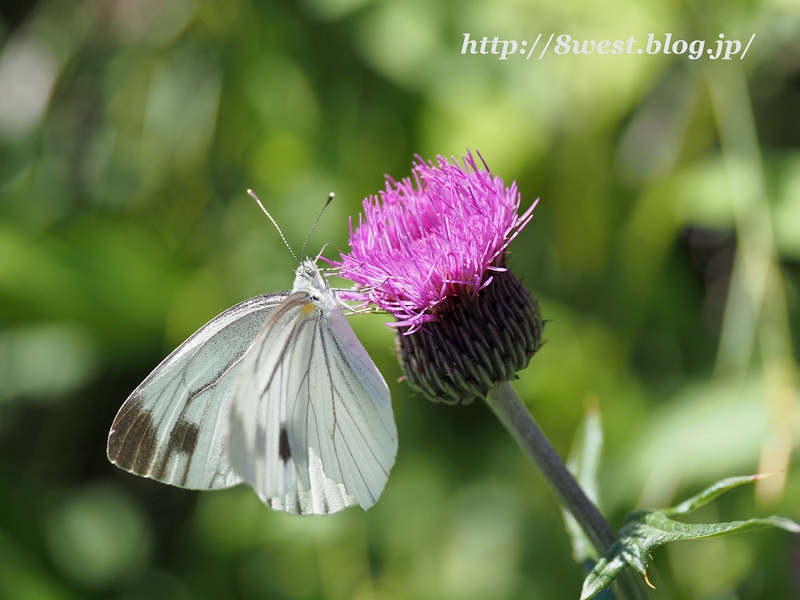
562, 405, 603, 563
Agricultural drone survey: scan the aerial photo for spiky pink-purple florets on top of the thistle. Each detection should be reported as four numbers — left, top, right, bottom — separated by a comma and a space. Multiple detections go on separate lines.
334, 152, 536, 334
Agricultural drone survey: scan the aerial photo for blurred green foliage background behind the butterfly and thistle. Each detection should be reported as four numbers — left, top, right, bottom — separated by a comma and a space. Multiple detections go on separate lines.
0, 0, 800, 600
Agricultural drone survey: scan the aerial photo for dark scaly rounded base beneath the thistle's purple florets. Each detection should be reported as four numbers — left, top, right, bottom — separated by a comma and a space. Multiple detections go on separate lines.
397, 259, 544, 405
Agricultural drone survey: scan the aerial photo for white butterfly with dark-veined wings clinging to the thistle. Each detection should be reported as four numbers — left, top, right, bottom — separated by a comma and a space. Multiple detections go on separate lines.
108, 259, 397, 514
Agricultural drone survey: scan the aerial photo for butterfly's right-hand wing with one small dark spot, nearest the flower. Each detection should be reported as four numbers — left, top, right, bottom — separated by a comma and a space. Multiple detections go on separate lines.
228, 292, 397, 514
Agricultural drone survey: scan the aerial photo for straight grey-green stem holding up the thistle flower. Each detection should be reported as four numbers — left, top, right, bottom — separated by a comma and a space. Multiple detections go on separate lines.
486, 381, 647, 600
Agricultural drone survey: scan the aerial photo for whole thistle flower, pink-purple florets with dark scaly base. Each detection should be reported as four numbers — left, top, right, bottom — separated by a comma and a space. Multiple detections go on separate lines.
334, 153, 542, 404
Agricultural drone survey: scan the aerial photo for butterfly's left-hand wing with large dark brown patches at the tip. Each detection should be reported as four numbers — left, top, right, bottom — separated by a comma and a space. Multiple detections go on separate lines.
108, 292, 289, 489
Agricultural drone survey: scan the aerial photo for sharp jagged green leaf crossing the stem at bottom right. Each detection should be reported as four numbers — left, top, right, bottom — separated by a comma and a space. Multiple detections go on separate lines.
581, 475, 800, 600
